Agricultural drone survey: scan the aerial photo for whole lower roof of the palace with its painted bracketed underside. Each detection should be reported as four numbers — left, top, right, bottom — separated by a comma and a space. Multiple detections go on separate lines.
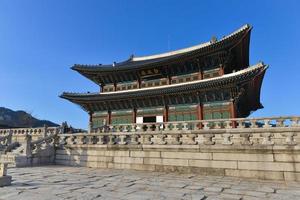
60, 63, 267, 116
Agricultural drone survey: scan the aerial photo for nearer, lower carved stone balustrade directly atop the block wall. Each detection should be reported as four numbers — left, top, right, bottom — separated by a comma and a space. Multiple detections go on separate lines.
59, 127, 300, 146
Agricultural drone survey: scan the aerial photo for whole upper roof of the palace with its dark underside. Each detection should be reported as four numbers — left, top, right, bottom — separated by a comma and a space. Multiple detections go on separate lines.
72, 24, 252, 84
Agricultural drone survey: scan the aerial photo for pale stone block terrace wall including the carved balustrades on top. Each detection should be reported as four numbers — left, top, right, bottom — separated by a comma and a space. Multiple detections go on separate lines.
55, 119, 300, 181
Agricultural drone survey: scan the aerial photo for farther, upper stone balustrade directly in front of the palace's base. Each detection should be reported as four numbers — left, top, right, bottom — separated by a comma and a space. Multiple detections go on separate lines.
91, 116, 300, 133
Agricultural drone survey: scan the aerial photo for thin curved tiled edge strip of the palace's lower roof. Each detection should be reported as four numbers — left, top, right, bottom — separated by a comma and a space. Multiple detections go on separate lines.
60, 63, 267, 105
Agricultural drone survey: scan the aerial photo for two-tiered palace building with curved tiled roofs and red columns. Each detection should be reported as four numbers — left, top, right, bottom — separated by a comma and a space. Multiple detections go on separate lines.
61, 24, 267, 128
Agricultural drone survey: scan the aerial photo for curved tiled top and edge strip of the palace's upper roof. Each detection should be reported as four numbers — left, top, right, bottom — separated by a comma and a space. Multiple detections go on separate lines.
71, 24, 252, 74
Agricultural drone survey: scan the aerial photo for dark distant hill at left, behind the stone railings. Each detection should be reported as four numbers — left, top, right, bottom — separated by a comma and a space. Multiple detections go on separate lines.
0, 107, 59, 128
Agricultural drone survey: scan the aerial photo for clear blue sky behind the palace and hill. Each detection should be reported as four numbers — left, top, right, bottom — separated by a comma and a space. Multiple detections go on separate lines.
0, 0, 300, 128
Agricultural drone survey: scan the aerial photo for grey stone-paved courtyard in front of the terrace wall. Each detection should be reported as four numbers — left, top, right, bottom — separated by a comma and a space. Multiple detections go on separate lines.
0, 166, 300, 200
